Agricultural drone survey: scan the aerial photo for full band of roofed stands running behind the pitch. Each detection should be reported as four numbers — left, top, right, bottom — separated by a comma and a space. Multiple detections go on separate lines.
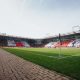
0, 32, 80, 48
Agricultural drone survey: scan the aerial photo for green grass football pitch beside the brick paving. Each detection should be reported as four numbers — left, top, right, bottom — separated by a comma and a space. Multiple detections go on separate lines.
4, 48, 80, 80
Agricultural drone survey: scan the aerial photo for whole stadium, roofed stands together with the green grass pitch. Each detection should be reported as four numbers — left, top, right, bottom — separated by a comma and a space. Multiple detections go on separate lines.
0, 31, 80, 80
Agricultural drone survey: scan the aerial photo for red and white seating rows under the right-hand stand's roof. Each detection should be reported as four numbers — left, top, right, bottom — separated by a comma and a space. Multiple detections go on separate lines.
45, 39, 80, 48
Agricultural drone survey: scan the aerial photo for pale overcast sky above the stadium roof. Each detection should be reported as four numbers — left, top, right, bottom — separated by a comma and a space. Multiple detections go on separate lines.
0, 0, 80, 38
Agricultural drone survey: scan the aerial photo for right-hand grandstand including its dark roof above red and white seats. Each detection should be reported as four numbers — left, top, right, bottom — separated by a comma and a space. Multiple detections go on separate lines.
45, 32, 80, 48
